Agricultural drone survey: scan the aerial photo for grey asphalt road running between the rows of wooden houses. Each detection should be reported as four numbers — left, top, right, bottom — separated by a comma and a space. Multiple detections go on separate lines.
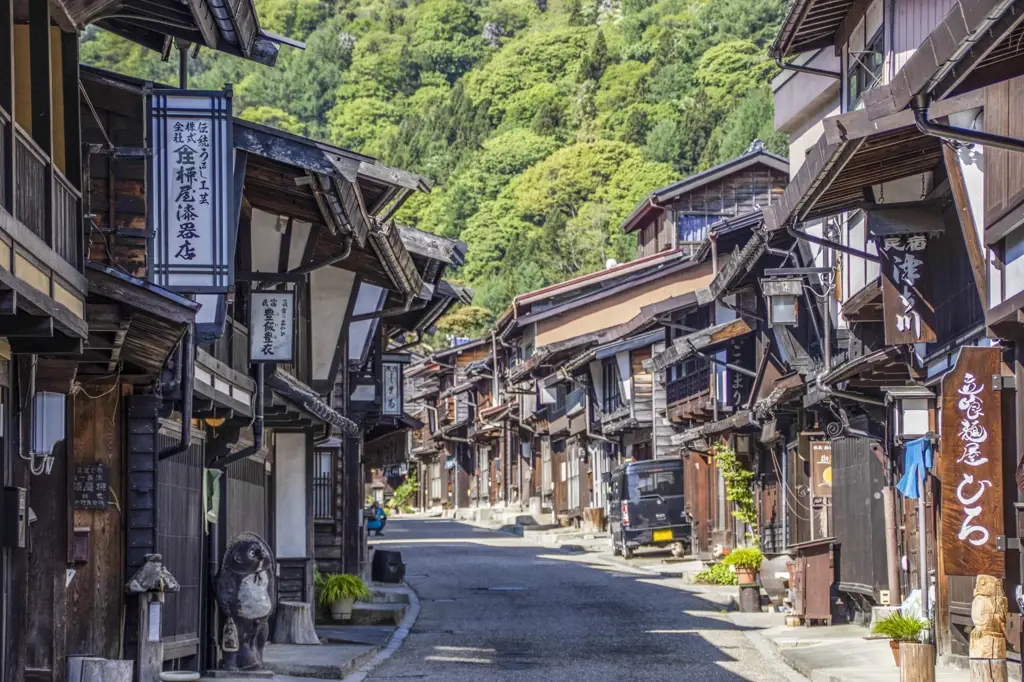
368, 519, 790, 682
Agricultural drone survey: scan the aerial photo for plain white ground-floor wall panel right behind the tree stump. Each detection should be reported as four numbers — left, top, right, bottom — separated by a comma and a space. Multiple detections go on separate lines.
273, 433, 309, 559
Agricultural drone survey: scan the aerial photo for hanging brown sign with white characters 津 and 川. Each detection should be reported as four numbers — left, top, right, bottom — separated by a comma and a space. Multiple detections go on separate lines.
879, 235, 936, 345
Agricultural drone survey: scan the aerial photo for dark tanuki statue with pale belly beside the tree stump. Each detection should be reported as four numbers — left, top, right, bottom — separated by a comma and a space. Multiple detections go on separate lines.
217, 532, 278, 670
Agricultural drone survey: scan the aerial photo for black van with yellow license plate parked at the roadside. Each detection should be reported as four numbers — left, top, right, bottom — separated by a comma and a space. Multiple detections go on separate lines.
608, 460, 692, 559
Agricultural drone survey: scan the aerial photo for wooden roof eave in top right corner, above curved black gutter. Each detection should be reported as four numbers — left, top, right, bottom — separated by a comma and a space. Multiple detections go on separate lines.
864, 0, 1024, 120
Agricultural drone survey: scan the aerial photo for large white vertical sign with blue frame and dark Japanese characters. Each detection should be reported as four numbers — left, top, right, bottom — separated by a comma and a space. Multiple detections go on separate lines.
146, 89, 236, 294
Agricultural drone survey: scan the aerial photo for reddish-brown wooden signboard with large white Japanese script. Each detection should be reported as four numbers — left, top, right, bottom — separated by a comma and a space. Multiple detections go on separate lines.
938, 346, 1006, 578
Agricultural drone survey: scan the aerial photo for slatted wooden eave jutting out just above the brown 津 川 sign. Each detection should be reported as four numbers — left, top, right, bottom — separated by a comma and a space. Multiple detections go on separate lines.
764, 91, 984, 228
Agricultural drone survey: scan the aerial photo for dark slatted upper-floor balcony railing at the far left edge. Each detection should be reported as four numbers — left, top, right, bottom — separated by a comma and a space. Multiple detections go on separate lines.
12, 125, 82, 269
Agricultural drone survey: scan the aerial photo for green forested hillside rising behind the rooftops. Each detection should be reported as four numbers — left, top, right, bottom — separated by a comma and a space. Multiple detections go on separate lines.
83, 0, 785, 327
